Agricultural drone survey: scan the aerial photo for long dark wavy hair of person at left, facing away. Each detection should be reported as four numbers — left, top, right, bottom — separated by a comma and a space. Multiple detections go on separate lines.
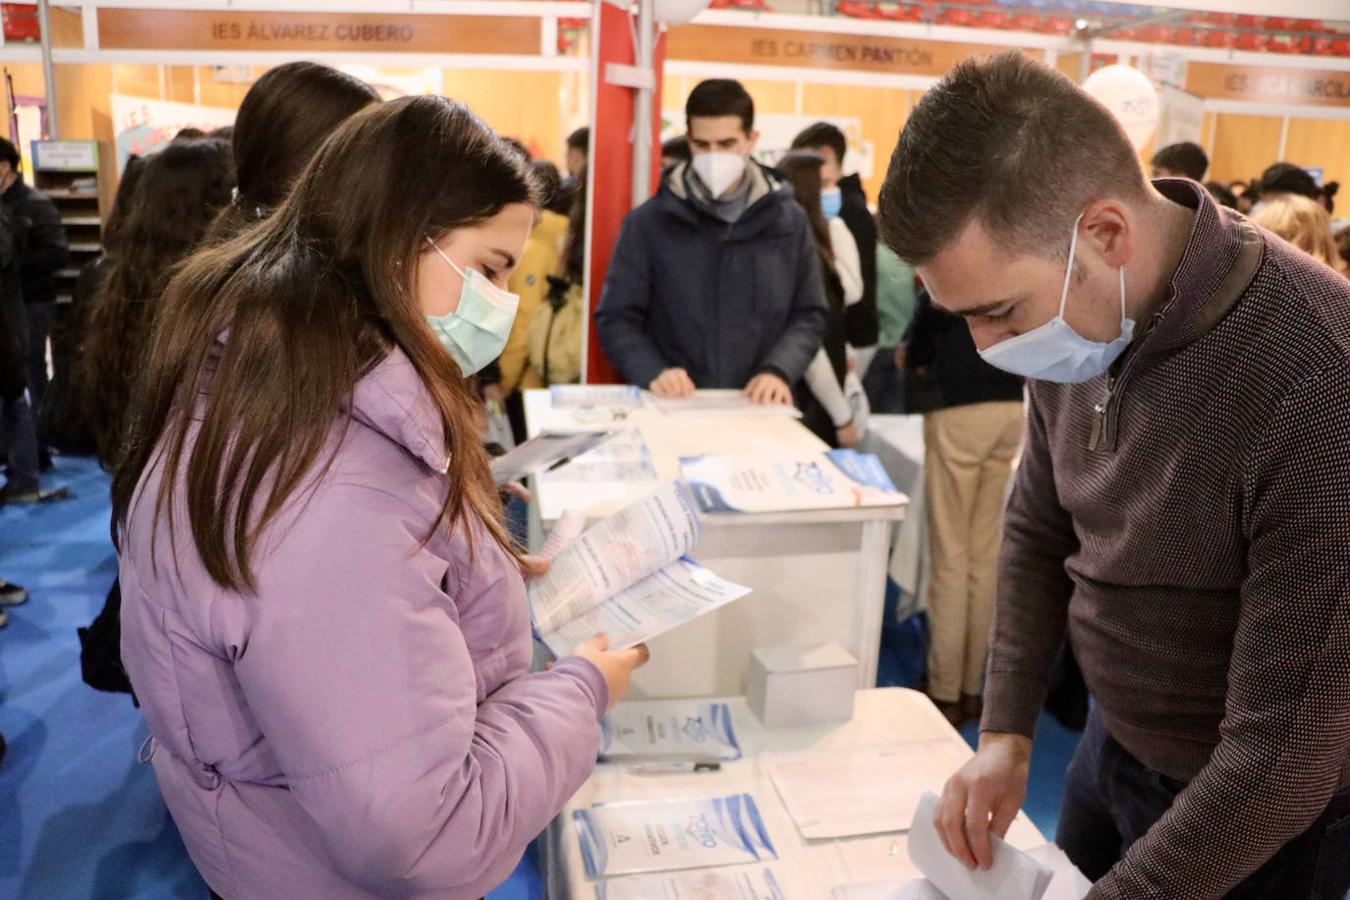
80, 139, 234, 467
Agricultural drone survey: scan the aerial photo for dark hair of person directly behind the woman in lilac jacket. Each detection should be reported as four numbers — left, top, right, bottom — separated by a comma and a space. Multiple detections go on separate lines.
212, 62, 379, 239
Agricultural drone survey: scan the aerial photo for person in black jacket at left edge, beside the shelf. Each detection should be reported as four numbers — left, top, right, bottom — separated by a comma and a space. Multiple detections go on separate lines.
0, 138, 70, 470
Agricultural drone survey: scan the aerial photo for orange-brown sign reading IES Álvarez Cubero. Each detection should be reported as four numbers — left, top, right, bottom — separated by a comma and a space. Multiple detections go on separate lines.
99, 8, 540, 55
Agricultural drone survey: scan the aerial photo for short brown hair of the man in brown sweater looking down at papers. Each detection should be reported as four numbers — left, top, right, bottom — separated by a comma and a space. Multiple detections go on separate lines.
878, 51, 1146, 263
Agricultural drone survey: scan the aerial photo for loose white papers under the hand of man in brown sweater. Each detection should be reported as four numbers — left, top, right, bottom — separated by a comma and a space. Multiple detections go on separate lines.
830, 792, 1092, 900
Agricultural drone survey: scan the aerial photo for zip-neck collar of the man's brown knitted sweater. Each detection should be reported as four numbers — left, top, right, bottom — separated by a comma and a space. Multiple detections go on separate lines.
1146, 178, 1265, 352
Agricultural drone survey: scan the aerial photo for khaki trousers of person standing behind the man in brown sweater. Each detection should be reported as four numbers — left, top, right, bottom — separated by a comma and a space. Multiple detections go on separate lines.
923, 402, 1023, 703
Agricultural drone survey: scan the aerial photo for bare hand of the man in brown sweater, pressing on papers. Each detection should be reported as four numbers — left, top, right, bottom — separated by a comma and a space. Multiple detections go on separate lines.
934, 731, 1031, 869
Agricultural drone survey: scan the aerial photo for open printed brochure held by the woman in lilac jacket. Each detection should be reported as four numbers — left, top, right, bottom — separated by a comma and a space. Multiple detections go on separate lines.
529, 482, 749, 656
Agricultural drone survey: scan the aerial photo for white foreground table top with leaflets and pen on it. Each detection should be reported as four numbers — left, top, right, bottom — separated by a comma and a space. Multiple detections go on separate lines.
541, 688, 1045, 900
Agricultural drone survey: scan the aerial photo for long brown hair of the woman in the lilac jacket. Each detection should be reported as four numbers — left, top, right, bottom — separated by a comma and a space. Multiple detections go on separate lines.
112, 97, 537, 590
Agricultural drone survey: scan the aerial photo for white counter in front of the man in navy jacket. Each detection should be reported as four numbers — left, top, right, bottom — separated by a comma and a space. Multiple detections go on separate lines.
525, 391, 905, 699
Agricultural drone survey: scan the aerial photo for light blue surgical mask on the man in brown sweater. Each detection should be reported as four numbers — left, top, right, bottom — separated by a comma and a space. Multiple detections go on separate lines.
980, 215, 1134, 385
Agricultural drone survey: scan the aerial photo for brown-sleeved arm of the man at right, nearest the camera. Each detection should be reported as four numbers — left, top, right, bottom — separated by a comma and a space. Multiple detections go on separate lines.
1088, 360, 1350, 900
